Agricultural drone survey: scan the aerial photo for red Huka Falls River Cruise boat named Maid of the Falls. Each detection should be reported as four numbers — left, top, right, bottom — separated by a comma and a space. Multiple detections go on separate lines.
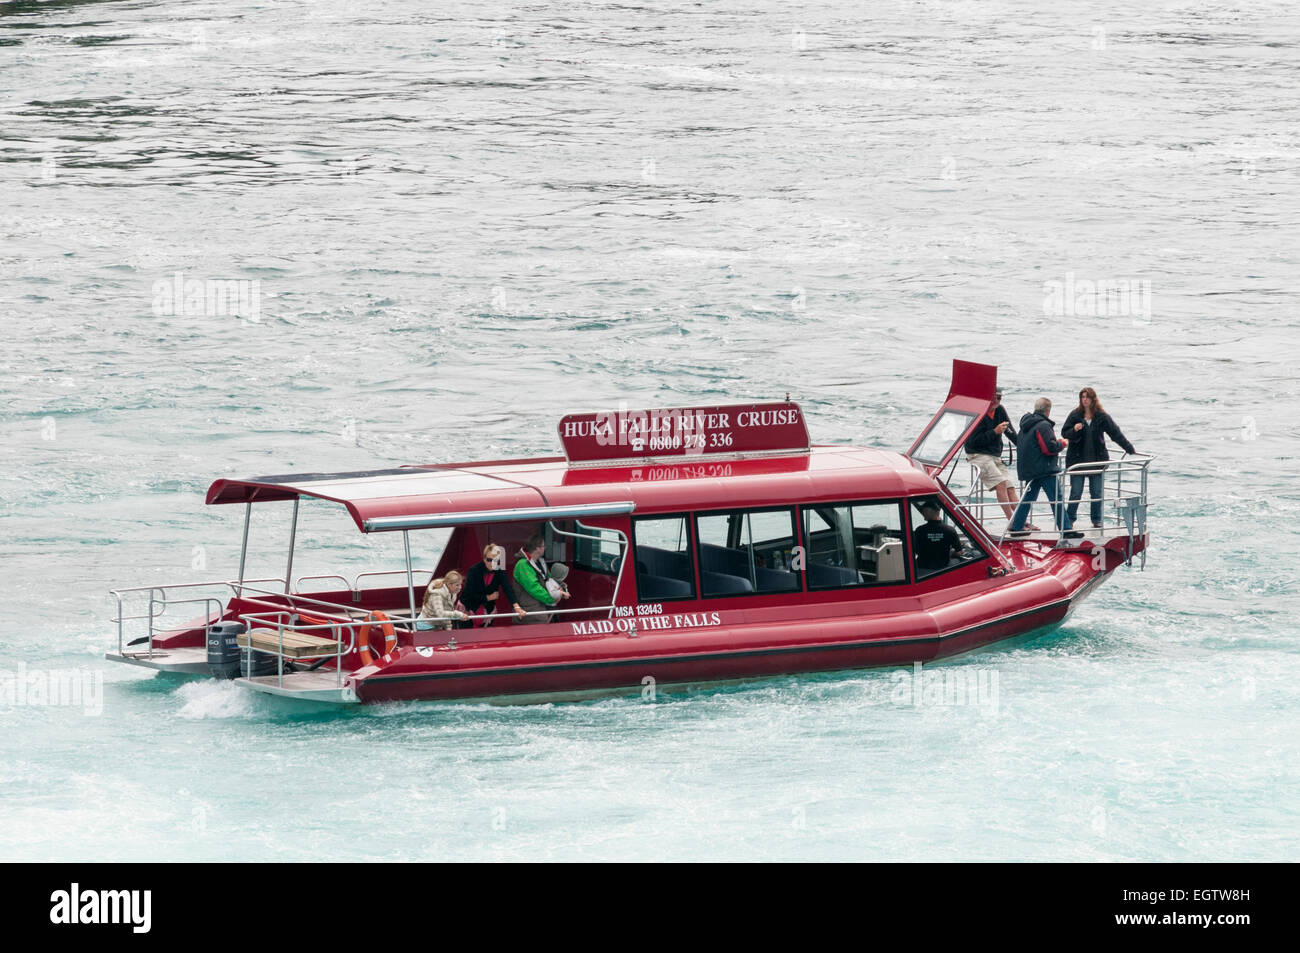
107, 360, 1151, 702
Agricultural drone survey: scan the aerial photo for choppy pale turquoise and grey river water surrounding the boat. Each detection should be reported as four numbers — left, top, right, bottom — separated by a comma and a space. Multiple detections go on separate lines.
0, 0, 1300, 861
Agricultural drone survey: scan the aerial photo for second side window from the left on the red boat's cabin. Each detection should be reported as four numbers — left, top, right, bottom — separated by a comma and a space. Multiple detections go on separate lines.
696, 510, 800, 597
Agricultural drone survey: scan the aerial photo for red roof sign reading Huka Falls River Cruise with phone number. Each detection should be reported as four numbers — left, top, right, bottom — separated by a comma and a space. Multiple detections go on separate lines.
559, 402, 809, 463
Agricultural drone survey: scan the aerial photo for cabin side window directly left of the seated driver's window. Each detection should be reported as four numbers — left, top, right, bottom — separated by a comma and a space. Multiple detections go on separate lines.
803, 502, 907, 589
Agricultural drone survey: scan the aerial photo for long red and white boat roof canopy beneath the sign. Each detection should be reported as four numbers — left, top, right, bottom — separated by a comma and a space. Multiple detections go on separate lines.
207, 446, 936, 533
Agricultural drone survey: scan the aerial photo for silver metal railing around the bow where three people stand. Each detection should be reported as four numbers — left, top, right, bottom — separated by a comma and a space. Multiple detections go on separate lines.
962, 454, 1154, 566
